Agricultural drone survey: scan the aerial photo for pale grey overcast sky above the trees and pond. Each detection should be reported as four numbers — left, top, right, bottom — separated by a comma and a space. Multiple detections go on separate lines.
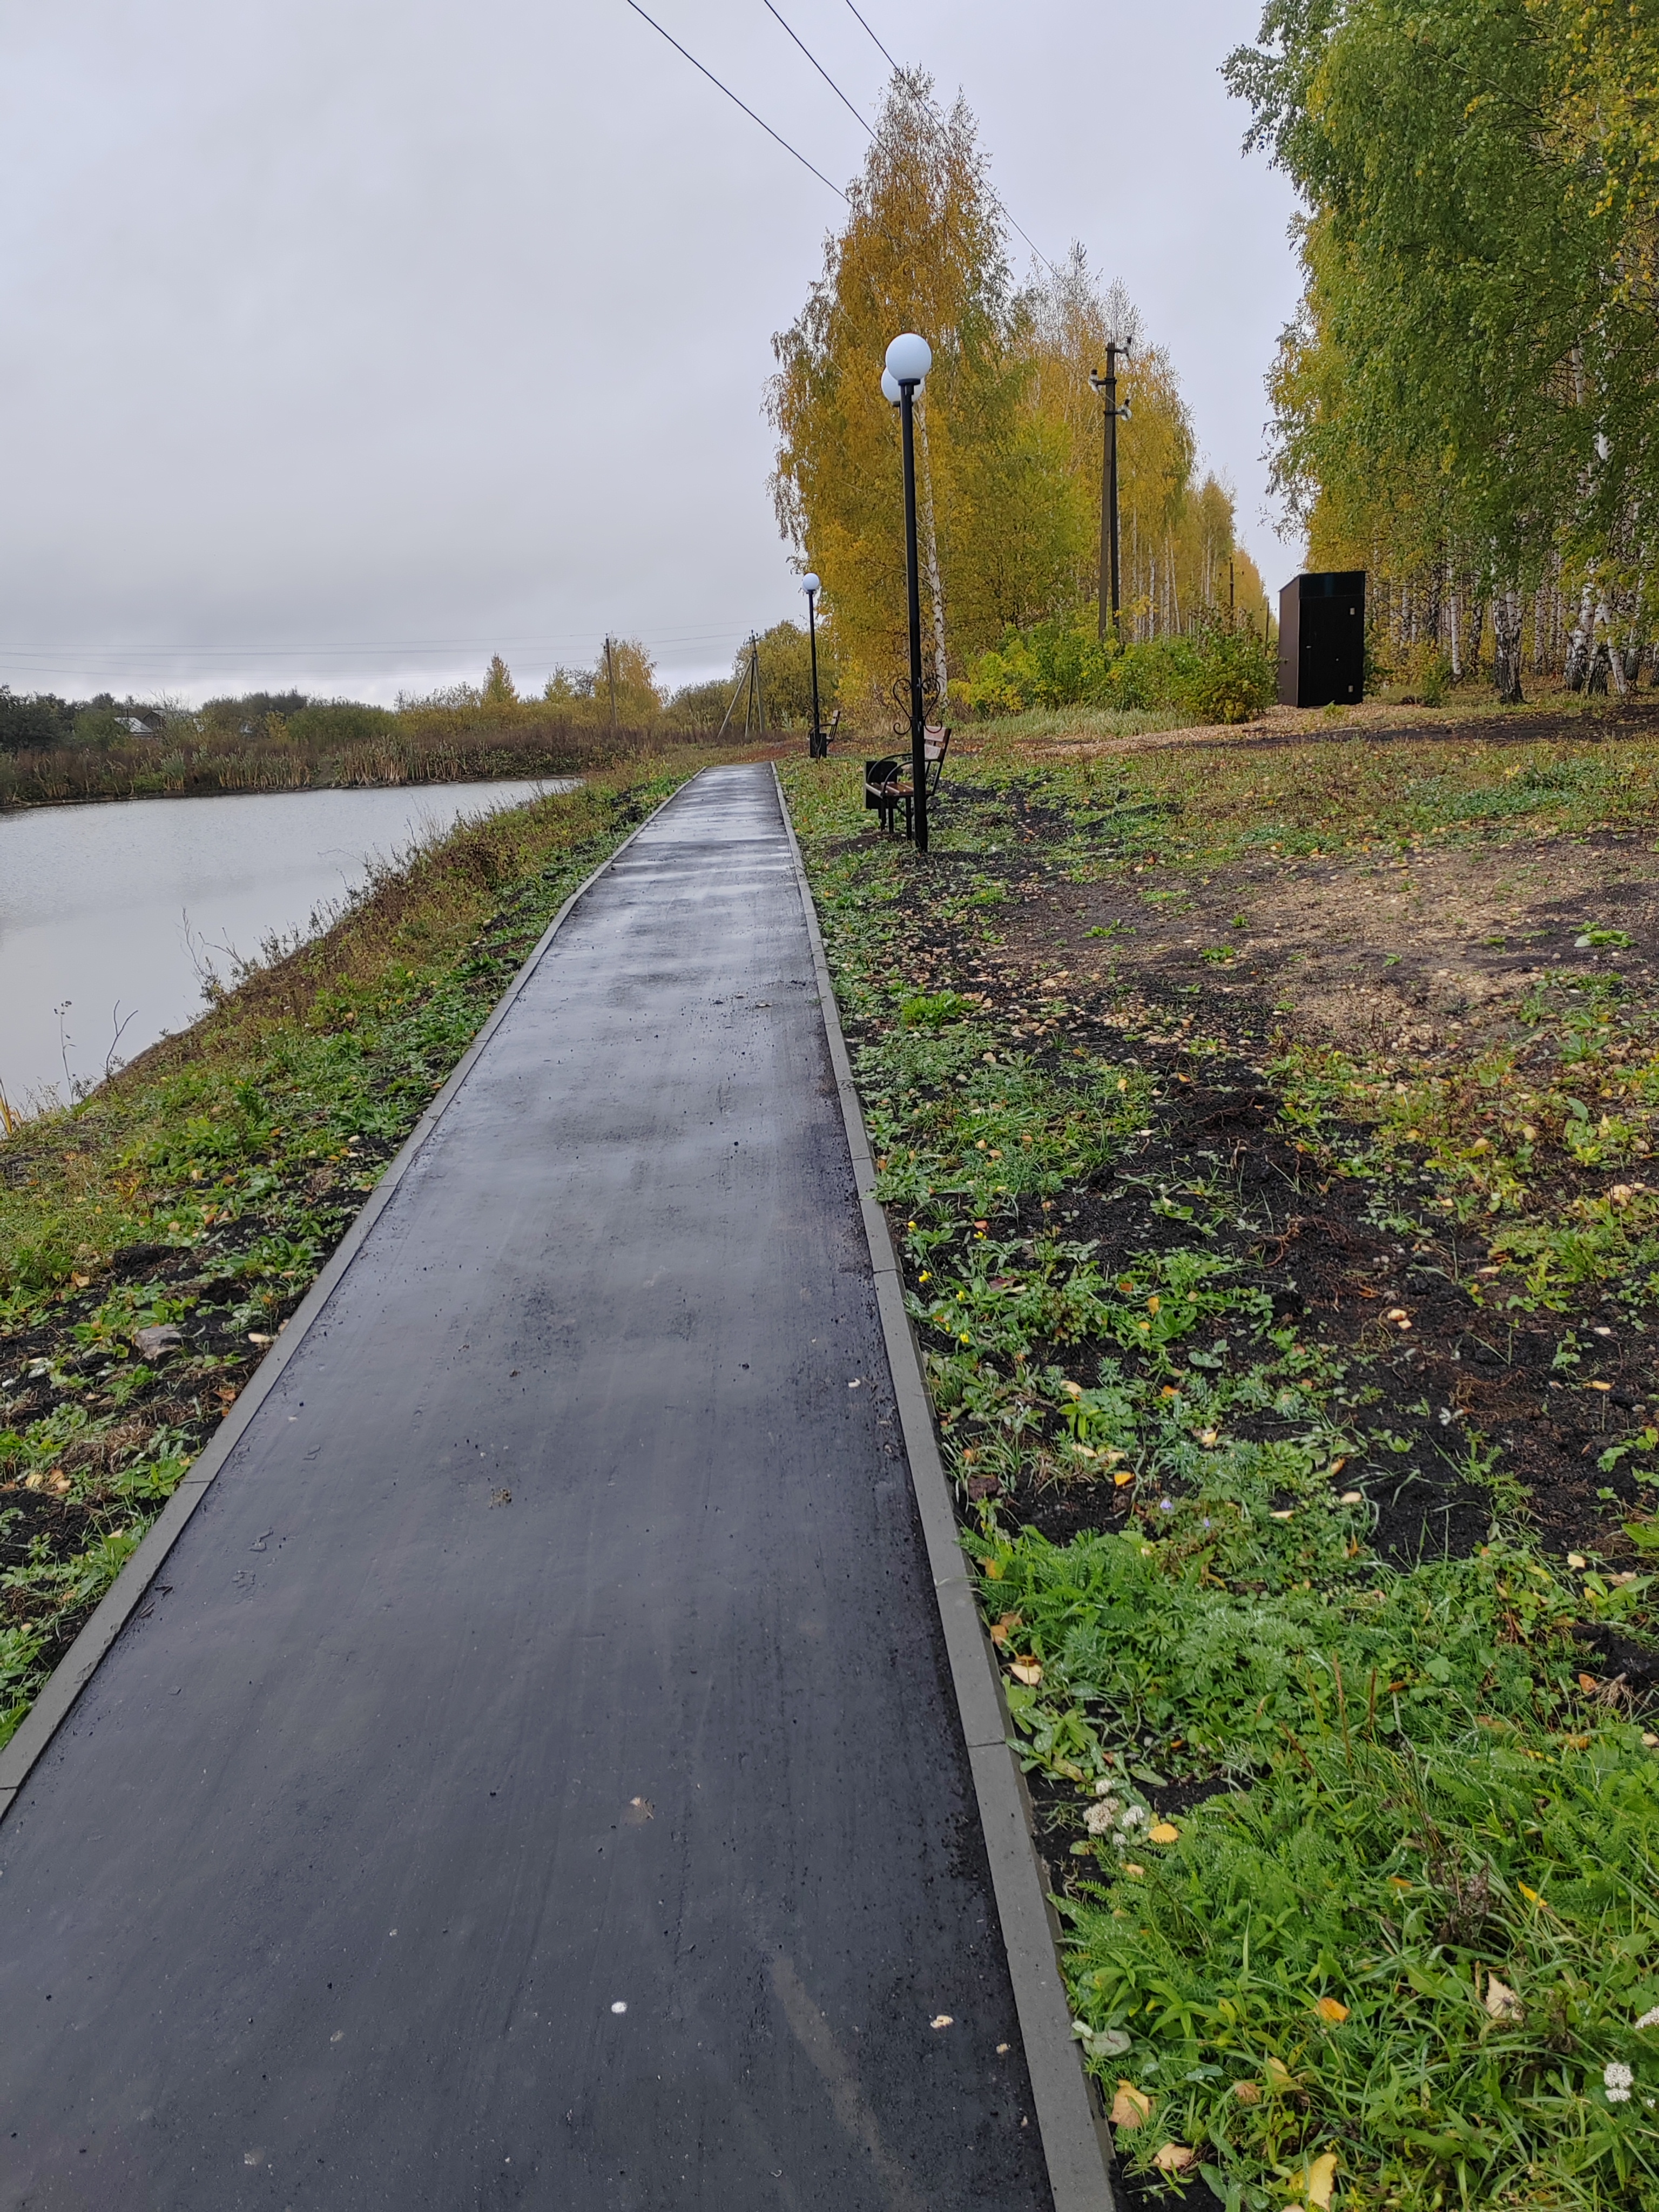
0, 0, 1298, 699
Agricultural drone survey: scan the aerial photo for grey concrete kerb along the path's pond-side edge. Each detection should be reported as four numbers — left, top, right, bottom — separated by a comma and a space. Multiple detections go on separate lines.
0, 767, 706, 1820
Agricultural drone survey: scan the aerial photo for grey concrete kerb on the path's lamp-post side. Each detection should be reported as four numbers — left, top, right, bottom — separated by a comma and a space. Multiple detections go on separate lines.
772, 767, 1117, 2212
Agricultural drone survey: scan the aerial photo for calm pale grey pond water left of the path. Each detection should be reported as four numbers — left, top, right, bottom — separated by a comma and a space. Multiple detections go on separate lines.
0, 781, 575, 1108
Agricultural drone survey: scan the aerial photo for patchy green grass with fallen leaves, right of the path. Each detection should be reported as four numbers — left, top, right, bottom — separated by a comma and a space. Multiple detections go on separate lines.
785, 730, 1659, 2212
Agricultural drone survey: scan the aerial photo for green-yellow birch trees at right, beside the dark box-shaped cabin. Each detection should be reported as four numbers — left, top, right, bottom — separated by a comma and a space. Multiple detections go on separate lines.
1228, 0, 1659, 699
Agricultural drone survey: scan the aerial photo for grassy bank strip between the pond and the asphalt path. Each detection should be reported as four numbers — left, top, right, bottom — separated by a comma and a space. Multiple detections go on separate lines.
0, 754, 699, 1741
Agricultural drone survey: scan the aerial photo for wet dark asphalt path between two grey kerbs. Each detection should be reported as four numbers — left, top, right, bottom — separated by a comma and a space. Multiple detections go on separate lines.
0, 767, 1051, 2212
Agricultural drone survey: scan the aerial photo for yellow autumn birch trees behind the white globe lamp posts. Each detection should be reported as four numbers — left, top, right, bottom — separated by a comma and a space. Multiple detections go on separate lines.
767, 71, 1265, 712
